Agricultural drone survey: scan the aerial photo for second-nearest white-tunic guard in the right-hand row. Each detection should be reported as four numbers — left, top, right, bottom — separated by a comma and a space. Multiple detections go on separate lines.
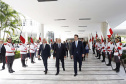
107, 38, 114, 66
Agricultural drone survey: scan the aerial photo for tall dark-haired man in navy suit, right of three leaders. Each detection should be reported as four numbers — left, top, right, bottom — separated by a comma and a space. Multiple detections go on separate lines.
71, 35, 84, 76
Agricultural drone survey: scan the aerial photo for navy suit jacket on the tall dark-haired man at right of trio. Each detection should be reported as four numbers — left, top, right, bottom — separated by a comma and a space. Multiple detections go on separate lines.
72, 41, 84, 58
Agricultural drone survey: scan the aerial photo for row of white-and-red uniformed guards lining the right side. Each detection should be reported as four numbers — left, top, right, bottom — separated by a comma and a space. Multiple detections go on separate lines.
92, 37, 123, 72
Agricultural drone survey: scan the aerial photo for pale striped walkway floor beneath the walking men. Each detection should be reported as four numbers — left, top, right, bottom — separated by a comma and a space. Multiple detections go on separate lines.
0, 53, 126, 84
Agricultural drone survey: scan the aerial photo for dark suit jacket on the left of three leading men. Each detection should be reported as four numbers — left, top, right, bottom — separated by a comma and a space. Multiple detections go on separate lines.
38, 44, 51, 58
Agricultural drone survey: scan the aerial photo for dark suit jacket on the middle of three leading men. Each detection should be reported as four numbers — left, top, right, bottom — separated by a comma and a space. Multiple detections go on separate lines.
55, 43, 66, 59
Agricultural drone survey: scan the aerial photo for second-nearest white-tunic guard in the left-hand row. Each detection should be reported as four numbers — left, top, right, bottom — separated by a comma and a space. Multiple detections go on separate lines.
19, 43, 27, 67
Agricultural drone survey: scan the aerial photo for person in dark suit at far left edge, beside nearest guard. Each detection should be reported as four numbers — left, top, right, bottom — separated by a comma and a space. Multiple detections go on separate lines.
0, 39, 6, 70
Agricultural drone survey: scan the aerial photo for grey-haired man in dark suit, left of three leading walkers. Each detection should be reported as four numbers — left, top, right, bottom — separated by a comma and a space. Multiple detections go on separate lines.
38, 38, 51, 74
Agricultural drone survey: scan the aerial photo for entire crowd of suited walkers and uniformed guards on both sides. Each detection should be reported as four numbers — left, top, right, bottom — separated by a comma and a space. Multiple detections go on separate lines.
0, 35, 122, 76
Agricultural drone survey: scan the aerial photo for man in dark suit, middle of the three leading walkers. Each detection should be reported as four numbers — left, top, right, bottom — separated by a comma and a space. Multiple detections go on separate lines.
55, 39, 66, 75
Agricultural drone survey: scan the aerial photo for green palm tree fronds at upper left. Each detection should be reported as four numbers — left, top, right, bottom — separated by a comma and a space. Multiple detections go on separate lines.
0, 0, 21, 40
